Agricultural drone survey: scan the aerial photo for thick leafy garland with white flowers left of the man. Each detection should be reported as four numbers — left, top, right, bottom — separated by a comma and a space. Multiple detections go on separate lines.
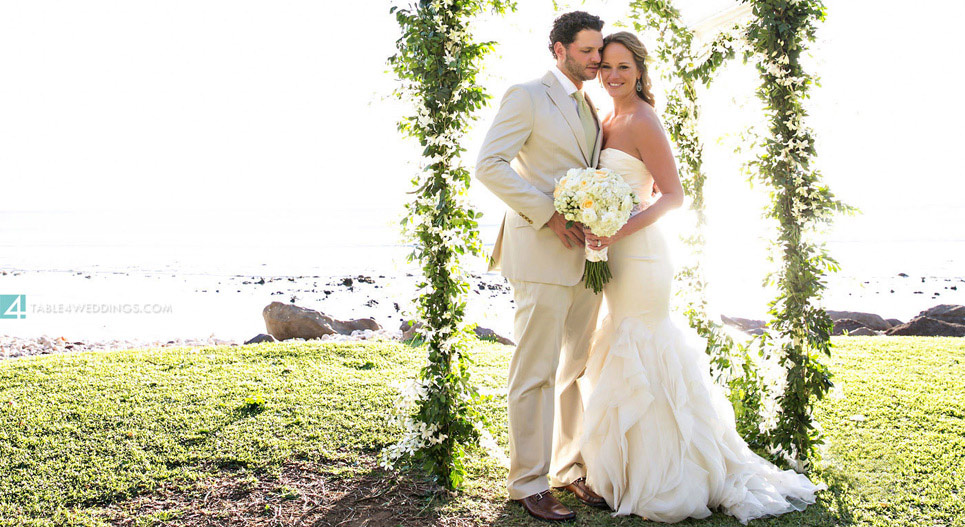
382, 0, 515, 489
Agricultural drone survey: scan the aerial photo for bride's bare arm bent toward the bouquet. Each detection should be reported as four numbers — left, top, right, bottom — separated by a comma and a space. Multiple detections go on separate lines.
586, 107, 684, 248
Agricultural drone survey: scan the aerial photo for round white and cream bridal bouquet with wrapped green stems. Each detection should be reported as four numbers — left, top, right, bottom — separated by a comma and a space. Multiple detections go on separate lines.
553, 168, 640, 293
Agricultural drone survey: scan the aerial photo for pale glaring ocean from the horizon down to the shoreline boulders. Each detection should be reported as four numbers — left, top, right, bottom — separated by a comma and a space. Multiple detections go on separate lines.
0, 209, 965, 339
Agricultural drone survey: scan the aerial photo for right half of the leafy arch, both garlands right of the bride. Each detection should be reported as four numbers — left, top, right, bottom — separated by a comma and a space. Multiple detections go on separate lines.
631, 0, 853, 471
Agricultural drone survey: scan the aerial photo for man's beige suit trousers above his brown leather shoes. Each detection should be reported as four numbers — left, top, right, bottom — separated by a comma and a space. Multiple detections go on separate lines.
507, 280, 603, 499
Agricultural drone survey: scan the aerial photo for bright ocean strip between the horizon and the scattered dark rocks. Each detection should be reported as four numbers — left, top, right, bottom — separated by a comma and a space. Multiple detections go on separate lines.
0, 207, 965, 277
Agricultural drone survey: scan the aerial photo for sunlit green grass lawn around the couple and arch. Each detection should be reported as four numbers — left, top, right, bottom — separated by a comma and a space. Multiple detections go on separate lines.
0, 337, 965, 527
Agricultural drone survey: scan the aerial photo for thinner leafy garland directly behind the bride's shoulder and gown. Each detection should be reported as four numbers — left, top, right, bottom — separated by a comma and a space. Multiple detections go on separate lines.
630, 0, 767, 452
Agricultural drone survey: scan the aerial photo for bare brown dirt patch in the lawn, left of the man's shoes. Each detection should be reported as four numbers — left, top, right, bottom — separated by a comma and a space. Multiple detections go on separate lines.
101, 460, 460, 527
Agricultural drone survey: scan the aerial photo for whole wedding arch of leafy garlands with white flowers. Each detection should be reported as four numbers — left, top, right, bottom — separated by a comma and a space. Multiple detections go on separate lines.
382, 0, 848, 489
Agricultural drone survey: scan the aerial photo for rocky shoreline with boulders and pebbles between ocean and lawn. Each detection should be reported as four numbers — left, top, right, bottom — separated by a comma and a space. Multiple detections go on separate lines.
0, 270, 965, 366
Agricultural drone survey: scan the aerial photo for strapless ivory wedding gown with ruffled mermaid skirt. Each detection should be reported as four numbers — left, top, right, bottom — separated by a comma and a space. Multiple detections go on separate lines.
581, 148, 827, 523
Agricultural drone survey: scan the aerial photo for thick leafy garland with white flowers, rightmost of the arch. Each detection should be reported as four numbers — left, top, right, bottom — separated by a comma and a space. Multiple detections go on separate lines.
742, 0, 853, 471
